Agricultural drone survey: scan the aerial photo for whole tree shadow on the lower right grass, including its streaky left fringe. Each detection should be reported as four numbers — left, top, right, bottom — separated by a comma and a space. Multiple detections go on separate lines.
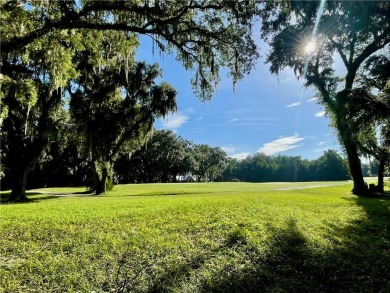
108, 198, 390, 292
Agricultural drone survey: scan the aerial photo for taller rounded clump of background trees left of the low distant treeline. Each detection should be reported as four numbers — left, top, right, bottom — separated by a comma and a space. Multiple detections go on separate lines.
115, 130, 227, 183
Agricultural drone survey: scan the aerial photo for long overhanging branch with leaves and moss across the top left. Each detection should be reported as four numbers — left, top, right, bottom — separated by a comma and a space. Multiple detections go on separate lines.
1, 0, 258, 99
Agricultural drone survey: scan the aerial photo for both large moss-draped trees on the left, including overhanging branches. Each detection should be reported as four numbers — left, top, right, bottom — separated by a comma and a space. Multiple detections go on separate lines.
0, 0, 258, 201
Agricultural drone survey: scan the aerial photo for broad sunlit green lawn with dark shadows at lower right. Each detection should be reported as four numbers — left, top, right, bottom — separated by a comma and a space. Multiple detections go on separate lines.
0, 182, 390, 292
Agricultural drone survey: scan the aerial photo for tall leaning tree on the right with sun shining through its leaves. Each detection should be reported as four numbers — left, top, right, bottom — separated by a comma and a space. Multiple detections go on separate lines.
261, 1, 390, 195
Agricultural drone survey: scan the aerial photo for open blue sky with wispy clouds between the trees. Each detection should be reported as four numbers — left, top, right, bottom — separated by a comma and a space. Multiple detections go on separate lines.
136, 38, 340, 159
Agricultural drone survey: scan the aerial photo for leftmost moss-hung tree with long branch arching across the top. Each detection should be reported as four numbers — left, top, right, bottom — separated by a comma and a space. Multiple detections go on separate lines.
0, 0, 258, 201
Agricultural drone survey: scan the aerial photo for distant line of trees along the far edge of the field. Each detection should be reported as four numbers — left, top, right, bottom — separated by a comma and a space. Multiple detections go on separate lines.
2, 130, 378, 190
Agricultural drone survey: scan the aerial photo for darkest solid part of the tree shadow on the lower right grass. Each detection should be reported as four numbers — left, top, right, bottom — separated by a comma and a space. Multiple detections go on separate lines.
202, 198, 390, 292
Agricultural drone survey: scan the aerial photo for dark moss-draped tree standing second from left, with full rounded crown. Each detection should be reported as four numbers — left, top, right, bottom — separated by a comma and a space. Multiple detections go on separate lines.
70, 32, 176, 195
